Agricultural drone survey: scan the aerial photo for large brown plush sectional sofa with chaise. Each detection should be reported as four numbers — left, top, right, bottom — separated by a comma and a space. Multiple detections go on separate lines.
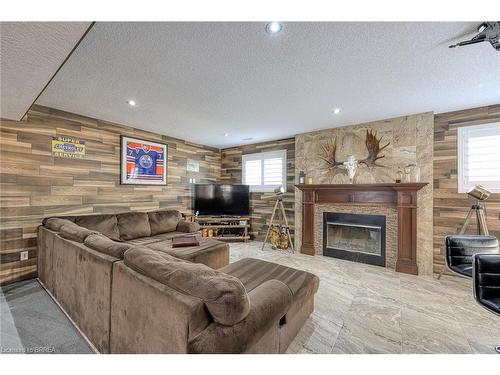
38, 210, 319, 353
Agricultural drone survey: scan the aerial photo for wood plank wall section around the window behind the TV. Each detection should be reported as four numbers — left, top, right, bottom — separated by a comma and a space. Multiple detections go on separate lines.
221, 138, 295, 240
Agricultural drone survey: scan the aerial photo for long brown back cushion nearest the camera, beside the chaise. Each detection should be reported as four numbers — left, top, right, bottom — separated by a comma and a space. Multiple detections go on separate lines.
124, 247, 250, 326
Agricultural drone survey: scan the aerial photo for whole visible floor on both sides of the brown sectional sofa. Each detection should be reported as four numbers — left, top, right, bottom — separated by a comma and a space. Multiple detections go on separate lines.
0, 242, 500, 353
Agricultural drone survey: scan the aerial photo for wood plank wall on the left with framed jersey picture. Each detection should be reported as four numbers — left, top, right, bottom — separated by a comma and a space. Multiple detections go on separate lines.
0, 106, 220, 284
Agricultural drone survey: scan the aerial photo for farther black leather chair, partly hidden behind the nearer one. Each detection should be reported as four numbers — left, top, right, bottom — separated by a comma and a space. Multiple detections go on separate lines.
438, 235, 500, 278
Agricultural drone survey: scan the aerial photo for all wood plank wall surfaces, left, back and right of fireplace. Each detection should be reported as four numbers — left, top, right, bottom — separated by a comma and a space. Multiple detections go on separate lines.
0, 104, 500, 285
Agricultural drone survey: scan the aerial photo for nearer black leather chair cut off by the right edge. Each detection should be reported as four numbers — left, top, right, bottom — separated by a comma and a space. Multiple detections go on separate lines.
472, 254, 500, 354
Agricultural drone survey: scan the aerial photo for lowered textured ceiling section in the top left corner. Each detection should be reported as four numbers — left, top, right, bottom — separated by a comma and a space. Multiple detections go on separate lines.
0, 22, 90, 120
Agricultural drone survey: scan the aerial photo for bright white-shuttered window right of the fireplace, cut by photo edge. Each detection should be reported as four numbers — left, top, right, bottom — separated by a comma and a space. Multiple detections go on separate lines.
458, 122, 500, 193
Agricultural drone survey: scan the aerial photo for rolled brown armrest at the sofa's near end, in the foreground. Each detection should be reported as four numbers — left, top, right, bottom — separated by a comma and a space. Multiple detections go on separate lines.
188, 280, 292, 353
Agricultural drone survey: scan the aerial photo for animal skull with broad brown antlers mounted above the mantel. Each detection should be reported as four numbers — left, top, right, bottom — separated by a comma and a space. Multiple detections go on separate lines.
319, 130, 391, 183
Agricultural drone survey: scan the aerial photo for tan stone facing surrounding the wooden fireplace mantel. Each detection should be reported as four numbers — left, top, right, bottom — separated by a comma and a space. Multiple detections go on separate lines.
295, 112, 434, 275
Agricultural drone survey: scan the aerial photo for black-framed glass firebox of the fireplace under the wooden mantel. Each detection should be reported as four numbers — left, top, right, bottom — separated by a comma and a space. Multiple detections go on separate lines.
323, 212, 386, 267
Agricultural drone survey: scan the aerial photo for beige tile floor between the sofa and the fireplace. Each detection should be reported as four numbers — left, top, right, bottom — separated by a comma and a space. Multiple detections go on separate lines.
231, 242, 500, 353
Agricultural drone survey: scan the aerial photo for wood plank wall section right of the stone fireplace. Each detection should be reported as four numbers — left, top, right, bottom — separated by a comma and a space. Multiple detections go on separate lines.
434, 104, 500, 272
